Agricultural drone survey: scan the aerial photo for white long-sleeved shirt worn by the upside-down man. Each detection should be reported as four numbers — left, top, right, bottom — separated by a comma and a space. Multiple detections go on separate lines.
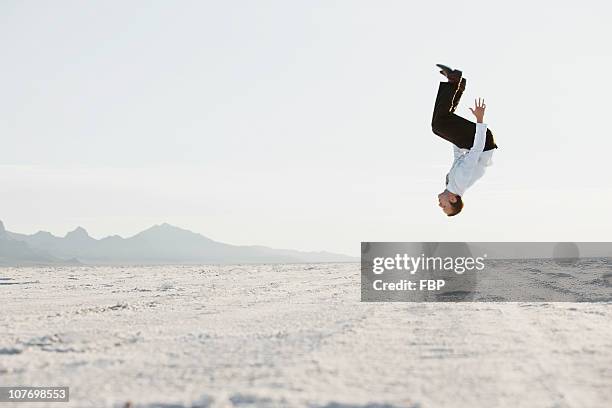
446, 123, 493, 197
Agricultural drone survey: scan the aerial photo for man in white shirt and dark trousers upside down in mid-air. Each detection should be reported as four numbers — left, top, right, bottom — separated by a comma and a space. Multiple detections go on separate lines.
431, 64, 497, 217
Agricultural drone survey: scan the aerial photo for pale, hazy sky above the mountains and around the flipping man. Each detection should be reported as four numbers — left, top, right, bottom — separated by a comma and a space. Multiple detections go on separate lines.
0, 0, 612, 255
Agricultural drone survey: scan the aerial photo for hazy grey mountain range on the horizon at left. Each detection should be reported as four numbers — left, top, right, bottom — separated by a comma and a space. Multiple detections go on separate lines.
0, 221, 359, 266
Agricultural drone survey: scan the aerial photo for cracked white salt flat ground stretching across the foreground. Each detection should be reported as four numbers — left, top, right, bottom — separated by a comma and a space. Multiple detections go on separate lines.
0, 264, 612, 408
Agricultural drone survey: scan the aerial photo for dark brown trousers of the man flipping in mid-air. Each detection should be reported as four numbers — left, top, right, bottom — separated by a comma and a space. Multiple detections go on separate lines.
431, 78, 497, 150
